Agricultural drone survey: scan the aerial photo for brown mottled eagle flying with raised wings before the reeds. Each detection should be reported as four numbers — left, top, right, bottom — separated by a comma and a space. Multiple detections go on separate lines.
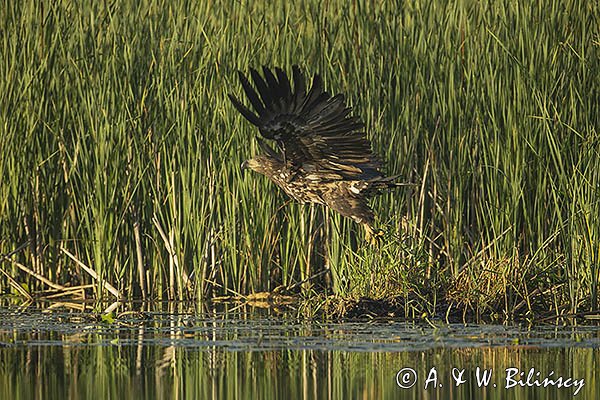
228, 65, 402, 243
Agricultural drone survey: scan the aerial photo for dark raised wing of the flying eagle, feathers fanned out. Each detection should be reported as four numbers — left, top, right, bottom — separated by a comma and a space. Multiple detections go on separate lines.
229, 66, 383, 179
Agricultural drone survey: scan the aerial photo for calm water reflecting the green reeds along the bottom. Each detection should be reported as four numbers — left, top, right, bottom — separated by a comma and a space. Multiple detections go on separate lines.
0, 308, 600, 399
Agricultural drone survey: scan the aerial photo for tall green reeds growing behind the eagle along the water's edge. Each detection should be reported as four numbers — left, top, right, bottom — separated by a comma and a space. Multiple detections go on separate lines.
0, 0, 600, 317
